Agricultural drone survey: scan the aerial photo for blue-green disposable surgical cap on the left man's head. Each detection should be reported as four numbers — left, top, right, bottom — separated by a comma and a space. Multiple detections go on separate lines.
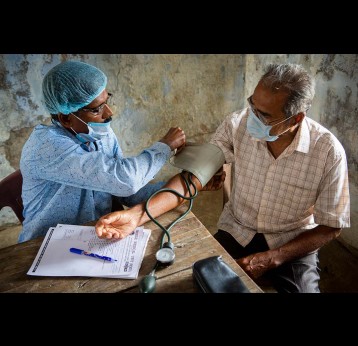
42, 61, 107, 114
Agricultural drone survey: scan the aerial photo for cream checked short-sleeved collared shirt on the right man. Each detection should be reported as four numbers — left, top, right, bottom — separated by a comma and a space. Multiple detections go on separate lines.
211, 108, 350, 249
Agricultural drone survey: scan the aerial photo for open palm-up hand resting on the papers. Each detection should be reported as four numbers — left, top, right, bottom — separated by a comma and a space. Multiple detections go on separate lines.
95, 209, 139, 239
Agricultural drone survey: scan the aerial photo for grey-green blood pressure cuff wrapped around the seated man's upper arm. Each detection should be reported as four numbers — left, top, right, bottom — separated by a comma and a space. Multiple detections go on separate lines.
170, 143, 225, 187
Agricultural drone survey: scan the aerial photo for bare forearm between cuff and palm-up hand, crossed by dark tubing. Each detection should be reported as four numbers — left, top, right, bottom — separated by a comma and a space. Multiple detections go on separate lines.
132, 173, 202, 226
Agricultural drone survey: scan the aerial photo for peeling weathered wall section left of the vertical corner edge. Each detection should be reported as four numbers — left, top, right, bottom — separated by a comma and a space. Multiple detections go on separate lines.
0, 54, 245, 227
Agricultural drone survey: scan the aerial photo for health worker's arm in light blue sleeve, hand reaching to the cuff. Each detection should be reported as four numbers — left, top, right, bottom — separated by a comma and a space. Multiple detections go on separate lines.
23, 128, 185, 197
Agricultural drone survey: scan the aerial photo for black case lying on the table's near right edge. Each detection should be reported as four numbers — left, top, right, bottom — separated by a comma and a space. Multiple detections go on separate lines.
192, 256, 250, 293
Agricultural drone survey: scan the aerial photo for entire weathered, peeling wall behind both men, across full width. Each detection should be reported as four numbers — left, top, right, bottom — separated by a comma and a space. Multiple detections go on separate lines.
0, 54, 358, 248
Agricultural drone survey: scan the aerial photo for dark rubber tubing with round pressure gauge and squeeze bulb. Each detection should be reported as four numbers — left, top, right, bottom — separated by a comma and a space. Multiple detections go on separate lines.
139, 171, 198, 293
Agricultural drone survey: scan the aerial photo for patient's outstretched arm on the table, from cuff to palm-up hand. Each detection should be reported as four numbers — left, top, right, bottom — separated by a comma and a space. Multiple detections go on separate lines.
95, 169, 225, 239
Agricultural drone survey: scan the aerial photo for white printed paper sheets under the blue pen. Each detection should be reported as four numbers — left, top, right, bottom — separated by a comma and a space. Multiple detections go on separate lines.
27, 224, 151, 279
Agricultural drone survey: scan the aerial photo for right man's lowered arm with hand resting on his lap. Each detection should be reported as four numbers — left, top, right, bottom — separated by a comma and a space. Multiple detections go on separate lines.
236, 225, 341, 279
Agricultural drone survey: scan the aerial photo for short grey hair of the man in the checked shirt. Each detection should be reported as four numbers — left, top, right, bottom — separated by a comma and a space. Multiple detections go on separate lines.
260, 64, 315, 117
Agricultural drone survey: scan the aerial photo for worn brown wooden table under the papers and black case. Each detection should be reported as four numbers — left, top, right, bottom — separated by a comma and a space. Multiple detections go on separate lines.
0, 205, 262, 293
